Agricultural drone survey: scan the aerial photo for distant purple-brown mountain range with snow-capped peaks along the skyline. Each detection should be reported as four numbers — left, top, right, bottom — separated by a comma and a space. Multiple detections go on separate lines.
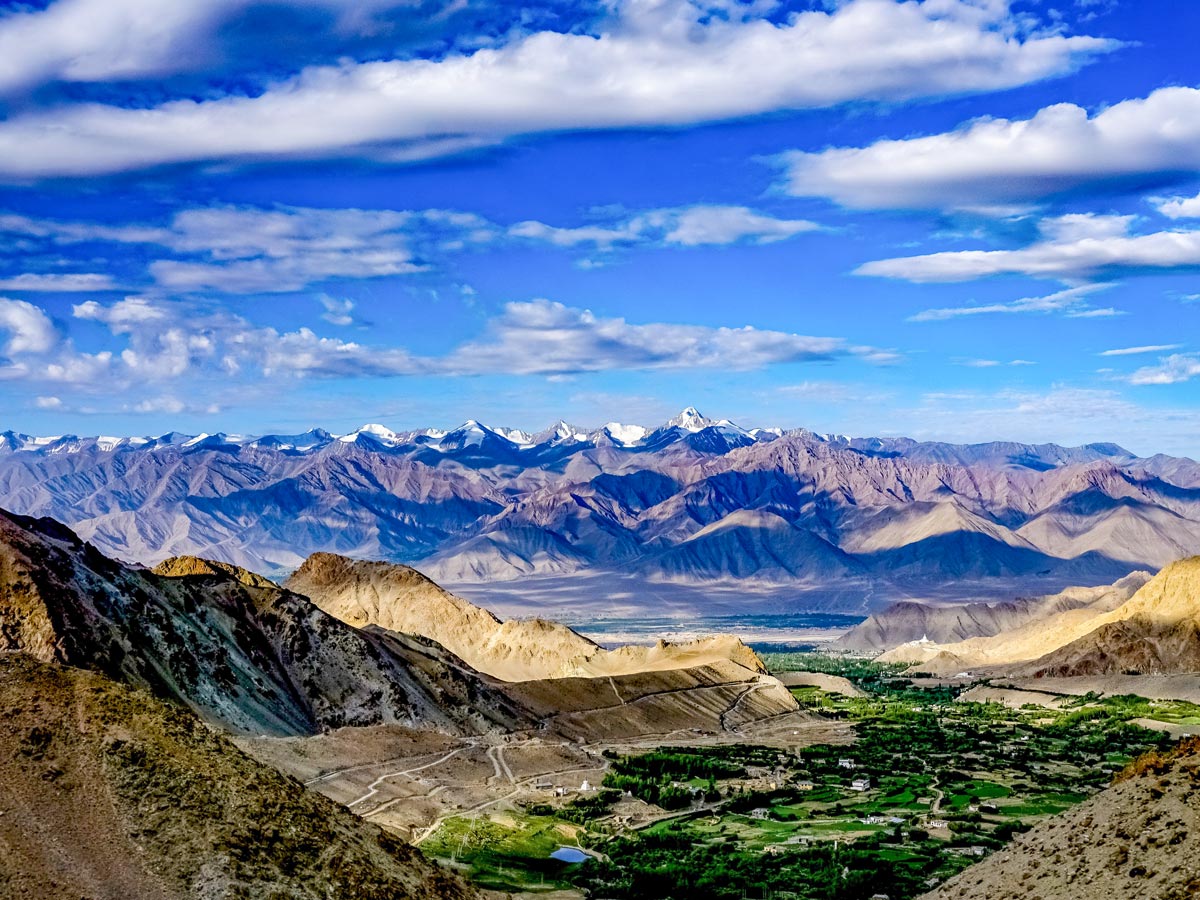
0, 408, 1200, 611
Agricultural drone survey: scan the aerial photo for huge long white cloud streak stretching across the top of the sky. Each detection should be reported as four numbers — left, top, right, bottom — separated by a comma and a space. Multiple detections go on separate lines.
0, 0, 1116, 178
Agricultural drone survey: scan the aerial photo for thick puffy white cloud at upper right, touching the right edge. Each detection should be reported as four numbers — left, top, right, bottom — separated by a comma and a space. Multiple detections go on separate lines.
780, 88, 1200, 209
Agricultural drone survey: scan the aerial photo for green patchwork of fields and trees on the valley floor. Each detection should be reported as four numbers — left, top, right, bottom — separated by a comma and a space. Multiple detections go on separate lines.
425, 654, 1176, 900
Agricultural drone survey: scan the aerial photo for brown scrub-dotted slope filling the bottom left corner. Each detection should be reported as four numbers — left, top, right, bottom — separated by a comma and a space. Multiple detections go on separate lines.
0, 654, 476, 900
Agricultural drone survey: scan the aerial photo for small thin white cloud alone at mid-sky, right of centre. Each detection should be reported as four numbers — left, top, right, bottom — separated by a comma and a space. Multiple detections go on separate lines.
509, 204, 820, 250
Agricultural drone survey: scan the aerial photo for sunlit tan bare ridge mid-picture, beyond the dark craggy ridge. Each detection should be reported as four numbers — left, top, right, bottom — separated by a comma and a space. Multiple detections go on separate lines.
287, 553, 763, 682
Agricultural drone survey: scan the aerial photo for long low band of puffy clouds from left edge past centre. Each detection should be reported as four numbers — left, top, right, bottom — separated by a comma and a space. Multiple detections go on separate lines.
0, 298, 898, 394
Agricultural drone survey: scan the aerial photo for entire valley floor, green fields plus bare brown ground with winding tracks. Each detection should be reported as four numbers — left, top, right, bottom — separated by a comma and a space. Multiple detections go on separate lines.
240, 654, 1200, 900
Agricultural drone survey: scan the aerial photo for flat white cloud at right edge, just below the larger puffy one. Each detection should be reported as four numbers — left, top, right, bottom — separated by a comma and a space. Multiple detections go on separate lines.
856, 214, 1200, 282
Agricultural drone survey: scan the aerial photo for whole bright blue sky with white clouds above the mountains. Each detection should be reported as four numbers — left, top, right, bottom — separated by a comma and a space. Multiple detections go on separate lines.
0, 0, 1200, 455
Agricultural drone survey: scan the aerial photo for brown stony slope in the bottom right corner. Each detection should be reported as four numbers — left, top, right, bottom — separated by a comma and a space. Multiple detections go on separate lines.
924, 740, 1200, 900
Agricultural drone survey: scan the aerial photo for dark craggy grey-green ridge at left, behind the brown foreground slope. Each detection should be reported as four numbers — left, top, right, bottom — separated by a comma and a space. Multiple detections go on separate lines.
0, 512, 526, 734
